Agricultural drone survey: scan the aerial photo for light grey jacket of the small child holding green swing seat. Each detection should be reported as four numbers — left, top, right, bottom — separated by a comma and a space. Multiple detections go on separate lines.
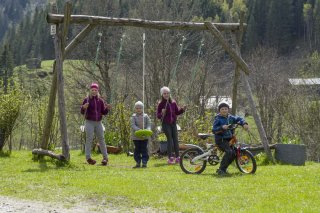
131, 113, 151, 140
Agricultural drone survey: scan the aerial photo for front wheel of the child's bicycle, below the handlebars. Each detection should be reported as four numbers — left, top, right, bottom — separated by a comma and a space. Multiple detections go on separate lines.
236, 150, 257, 174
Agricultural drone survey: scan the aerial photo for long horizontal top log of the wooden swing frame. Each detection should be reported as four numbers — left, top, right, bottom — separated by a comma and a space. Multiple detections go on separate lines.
47, 13, 244, 31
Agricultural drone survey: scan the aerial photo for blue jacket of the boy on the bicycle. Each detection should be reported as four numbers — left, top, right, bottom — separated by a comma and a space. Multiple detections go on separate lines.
212, 114, 247, 140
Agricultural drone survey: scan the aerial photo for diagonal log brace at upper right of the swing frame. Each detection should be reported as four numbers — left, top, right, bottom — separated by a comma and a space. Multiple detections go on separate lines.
205, 22, 249, 75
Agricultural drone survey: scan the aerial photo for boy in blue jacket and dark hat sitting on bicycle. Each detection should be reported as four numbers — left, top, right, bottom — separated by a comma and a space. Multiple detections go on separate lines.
212, 102, 249, 175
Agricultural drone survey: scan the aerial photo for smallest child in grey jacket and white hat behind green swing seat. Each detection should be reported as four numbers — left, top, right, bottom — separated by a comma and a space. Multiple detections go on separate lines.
131, 101, 151, 169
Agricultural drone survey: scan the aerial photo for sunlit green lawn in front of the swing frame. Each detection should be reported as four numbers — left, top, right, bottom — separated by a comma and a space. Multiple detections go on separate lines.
0, 151, 320, 212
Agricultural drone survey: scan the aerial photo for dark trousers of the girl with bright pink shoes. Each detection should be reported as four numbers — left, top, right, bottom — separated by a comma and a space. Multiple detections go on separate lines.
162, 122, 179, 158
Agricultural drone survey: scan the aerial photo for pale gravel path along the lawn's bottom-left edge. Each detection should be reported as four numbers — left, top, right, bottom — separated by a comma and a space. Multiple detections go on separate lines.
0, 196, 159, 213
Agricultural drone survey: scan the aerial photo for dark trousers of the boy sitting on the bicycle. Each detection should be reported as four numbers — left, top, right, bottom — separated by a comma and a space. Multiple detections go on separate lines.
216, 138, 236, 171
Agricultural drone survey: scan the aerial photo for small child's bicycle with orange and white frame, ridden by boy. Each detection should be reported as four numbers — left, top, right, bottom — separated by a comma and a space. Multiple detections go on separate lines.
180, 125, 257, 174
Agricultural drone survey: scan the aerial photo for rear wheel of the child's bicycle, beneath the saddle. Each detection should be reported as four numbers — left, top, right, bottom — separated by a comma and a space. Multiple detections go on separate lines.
180, 148, 207, 174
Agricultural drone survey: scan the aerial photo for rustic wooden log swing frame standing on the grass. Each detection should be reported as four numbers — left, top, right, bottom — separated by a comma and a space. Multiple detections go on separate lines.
32, 1, 274, 162
